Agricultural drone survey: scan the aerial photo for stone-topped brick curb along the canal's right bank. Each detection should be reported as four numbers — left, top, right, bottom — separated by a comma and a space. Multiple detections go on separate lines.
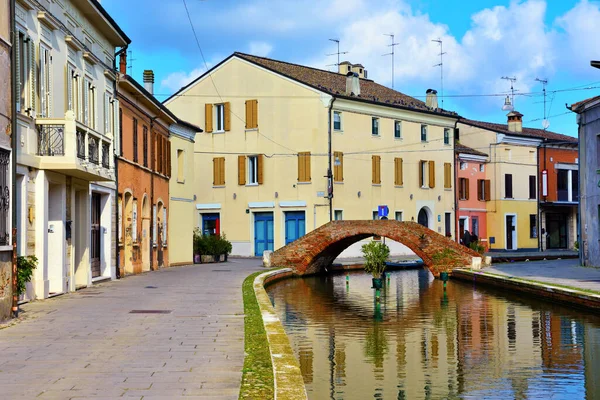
452, 269, 600, 313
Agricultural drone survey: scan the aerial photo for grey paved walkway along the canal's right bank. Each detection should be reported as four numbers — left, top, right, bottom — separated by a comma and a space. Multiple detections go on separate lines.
482, 259, 600, 293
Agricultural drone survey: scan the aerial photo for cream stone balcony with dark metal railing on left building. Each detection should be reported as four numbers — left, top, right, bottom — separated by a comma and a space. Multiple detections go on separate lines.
30, 118, 115, 181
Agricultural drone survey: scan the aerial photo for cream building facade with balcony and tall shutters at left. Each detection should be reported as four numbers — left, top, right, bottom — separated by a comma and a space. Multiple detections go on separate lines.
15, 0, 130, 298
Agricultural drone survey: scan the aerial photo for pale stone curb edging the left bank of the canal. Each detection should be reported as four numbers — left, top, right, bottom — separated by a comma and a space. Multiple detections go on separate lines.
254, 268, 308, 400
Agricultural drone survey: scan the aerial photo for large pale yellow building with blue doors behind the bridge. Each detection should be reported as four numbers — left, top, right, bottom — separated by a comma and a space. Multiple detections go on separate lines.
165, 53, 458, 256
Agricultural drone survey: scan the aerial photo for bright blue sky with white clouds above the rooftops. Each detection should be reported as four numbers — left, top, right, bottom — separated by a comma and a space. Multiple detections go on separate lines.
102, 0, 600, 136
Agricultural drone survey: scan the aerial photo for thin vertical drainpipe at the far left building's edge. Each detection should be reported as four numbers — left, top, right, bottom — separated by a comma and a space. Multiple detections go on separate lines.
9, 0, 19, 318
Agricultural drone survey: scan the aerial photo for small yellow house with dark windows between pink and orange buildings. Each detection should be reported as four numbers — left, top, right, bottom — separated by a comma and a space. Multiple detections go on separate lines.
458, 111, 550, 250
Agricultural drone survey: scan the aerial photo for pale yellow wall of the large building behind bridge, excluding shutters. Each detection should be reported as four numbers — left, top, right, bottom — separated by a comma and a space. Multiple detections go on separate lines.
165, 57, 454, 255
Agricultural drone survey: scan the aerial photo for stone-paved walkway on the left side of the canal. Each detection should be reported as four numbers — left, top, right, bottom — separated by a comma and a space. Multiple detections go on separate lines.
0, 259, 261, 400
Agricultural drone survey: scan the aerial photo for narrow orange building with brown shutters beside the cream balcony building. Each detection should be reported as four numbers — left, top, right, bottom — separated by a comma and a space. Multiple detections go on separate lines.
117, 53, 177, 275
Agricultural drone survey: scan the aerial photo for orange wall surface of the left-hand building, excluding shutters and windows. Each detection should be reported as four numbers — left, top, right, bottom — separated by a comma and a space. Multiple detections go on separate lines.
118, 99, 169, 275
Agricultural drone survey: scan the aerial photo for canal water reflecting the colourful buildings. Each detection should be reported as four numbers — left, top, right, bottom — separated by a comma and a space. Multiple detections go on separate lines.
267, 270, 600, 400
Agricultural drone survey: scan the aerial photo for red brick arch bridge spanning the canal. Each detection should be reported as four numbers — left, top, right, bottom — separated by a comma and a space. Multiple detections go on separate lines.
271, 220, 481, 277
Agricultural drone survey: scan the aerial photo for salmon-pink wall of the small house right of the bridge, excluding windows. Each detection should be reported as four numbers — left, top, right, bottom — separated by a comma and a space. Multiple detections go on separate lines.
455, 161, 490, 245
